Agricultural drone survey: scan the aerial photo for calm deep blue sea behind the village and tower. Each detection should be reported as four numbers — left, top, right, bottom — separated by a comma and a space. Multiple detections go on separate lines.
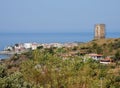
0, 32, 120, 59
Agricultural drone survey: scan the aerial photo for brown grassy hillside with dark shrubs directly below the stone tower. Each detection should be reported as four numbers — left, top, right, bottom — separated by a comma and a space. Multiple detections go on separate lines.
79, 38, 120, 56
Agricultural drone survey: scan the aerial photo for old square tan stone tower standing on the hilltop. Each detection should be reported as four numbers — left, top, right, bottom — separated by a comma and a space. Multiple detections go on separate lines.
94, 24, 105, 39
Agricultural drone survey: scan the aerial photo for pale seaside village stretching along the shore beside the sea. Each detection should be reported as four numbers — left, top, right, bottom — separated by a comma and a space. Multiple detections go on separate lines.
4, 43, 78, 52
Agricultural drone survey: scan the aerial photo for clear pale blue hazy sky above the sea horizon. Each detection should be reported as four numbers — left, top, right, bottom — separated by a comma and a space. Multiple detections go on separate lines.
0, 0, 120, 32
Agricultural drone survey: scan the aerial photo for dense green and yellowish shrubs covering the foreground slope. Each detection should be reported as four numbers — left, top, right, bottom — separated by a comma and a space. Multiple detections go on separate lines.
0, 39, 120, 88
